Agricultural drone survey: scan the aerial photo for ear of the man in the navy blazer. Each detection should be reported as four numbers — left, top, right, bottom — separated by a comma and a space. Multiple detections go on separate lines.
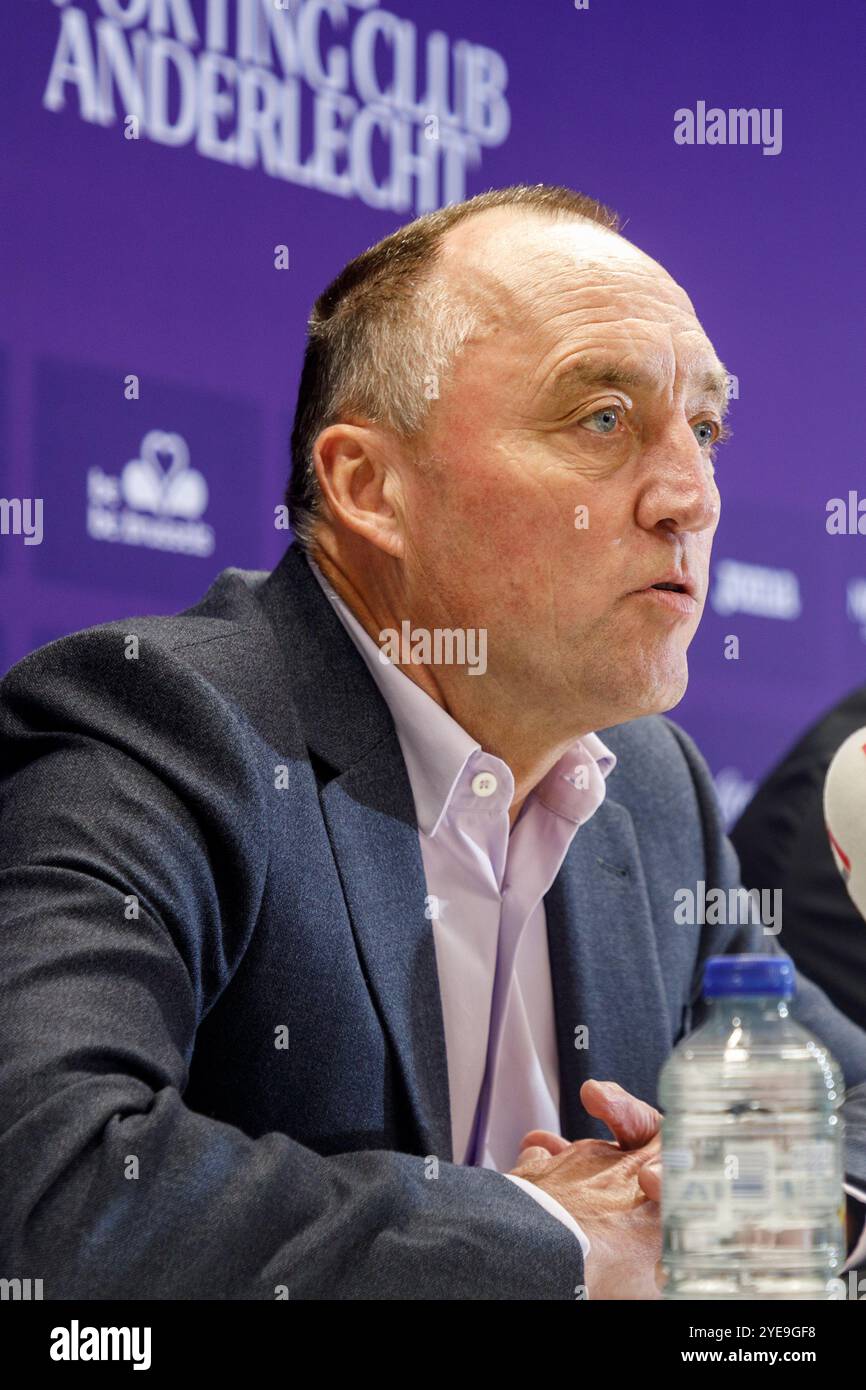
313, 421, 403, 559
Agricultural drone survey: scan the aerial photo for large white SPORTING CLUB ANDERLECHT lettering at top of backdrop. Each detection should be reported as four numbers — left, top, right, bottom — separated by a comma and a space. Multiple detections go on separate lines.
43, 0, 510, 213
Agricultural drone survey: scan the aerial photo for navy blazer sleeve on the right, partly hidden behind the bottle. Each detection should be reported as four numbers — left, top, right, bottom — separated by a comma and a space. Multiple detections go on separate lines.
669, 721, 866, 1187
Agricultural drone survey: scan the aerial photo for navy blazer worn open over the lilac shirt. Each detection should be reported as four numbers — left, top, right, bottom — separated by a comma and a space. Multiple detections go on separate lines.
0, 536, 866, 1300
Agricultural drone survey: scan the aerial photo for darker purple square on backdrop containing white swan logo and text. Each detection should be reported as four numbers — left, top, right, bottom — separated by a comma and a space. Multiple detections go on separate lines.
34, 357, 264, 586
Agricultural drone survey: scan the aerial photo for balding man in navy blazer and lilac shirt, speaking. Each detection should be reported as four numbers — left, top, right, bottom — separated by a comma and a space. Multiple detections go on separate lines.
0, 186, 866, 1298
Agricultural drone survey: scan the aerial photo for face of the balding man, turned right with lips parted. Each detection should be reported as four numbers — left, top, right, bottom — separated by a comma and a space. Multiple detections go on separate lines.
403, 209, 724, 728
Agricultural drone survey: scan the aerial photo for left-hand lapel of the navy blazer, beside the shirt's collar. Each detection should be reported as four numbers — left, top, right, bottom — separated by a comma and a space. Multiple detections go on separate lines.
255, 548, 452, 1161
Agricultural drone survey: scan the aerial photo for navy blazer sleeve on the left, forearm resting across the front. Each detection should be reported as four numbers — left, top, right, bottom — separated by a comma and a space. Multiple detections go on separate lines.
0, 624, 584, 1300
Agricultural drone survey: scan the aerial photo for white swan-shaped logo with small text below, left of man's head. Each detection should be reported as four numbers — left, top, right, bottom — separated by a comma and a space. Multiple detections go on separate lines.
88, 430, 214, 556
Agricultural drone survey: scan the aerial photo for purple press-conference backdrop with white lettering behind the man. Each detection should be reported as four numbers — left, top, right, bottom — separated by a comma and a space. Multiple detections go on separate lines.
0, 0, 866, 815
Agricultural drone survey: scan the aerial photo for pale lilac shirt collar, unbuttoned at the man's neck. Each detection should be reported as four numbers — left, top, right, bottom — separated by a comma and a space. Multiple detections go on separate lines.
307, 556, 617, 835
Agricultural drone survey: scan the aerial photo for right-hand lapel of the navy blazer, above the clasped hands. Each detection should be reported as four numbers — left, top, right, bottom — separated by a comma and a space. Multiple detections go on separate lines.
545, 799, 671, 1140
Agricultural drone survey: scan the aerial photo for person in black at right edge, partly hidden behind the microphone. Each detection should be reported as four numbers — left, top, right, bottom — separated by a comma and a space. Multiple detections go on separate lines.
731, 685, 866, 1029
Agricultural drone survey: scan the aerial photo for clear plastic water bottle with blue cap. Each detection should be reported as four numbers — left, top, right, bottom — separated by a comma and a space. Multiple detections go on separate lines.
659, 955, 845, 1300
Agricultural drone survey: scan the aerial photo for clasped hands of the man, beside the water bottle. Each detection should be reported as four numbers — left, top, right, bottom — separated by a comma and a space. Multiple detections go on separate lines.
512, 1081, 662, 1300
